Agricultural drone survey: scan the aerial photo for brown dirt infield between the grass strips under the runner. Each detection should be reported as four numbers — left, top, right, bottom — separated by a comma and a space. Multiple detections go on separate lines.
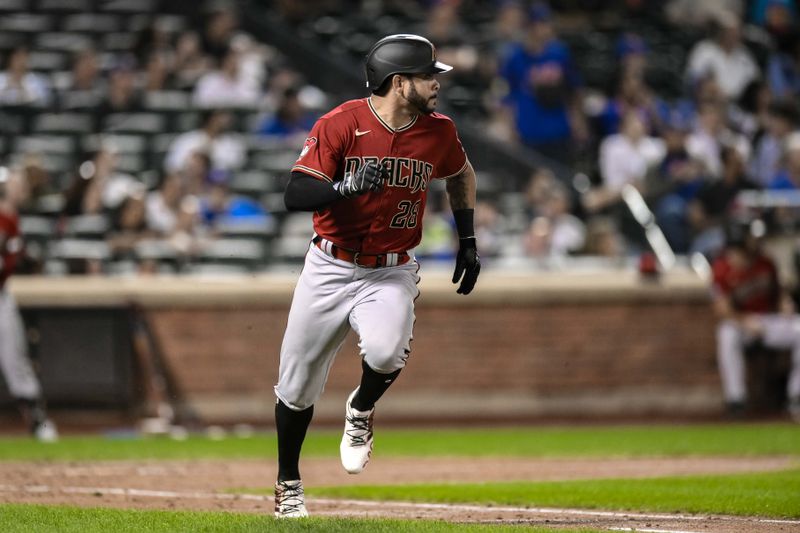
0, 457, 800, 533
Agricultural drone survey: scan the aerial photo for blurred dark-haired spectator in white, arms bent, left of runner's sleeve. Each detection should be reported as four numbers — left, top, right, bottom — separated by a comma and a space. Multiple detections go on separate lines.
164, 109, 247, 172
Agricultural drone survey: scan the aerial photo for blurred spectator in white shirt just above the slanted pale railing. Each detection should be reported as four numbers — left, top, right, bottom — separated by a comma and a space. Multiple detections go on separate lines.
585, 112, 666, 211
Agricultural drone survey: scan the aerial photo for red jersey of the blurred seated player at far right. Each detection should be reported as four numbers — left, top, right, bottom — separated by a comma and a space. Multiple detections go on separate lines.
713, 255, 780, 313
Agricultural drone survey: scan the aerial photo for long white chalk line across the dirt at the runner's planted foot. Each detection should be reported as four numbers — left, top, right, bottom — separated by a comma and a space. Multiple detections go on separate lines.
0, 484, 800, 533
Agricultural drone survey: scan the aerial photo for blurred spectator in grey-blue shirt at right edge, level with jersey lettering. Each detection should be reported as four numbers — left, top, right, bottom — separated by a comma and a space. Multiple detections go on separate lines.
750, 101, 800, 187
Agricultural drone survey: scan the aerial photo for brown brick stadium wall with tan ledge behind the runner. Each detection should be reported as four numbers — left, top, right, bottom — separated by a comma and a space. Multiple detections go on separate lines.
7, 272, 720, 422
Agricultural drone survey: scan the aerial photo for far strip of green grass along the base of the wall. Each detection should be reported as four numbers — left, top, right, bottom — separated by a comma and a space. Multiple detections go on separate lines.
0, 424, 800, 461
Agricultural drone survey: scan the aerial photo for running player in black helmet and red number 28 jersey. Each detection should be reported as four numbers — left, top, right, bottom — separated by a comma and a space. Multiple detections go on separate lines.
275, 34, 480, 518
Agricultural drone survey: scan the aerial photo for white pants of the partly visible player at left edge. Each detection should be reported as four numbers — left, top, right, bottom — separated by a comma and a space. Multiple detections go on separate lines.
0, 289, 41, 400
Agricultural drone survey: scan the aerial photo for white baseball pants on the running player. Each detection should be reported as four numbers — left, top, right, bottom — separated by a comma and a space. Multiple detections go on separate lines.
275, 244, 419, 411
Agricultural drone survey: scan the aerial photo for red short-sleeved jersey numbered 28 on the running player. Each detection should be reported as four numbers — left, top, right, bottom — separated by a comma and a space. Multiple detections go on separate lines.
292, 98, 467, 254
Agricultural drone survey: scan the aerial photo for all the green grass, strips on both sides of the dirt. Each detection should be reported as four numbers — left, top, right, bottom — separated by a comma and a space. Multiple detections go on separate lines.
0, 424, 800, 533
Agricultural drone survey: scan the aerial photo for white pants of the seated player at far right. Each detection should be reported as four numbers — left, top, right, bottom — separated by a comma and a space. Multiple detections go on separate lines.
717, 314, 800, 402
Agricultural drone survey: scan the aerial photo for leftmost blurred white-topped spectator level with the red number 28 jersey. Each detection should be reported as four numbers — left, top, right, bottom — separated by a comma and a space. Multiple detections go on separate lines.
62, 146, 145, 216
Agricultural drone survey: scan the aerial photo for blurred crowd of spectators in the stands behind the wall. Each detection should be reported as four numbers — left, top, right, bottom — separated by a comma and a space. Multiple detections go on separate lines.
0, 0, 800, 275
